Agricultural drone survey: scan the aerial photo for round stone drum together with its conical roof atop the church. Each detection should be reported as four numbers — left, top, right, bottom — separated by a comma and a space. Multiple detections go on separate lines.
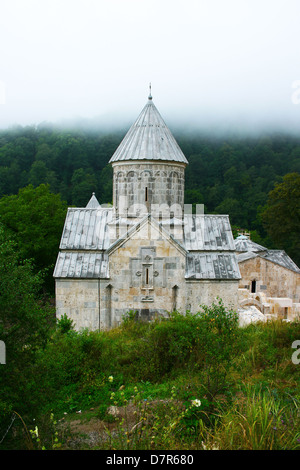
109, 95, 188, 217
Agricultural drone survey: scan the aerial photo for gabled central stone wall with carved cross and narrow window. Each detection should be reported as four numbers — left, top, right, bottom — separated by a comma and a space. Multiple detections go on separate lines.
110, 219, 185, 325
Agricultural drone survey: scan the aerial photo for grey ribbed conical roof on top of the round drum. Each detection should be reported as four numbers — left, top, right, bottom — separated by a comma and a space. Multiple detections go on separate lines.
109, 96, 188, 164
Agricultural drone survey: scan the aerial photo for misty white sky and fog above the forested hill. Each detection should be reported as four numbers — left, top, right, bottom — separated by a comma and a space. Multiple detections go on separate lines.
0, 0, 300, 133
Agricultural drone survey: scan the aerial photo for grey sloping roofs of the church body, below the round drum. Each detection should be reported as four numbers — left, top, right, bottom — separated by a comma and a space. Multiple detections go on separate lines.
54, 198, 240, 280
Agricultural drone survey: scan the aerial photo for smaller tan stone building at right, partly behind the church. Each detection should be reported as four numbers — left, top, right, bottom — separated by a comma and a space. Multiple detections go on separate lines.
235, 235, 300, 319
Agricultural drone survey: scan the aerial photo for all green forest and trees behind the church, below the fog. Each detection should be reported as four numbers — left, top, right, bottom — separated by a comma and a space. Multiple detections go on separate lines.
0, 125, 300, 290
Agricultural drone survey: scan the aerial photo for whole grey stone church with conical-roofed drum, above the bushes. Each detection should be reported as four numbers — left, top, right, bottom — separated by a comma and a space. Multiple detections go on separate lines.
54, 93, 241, 330
